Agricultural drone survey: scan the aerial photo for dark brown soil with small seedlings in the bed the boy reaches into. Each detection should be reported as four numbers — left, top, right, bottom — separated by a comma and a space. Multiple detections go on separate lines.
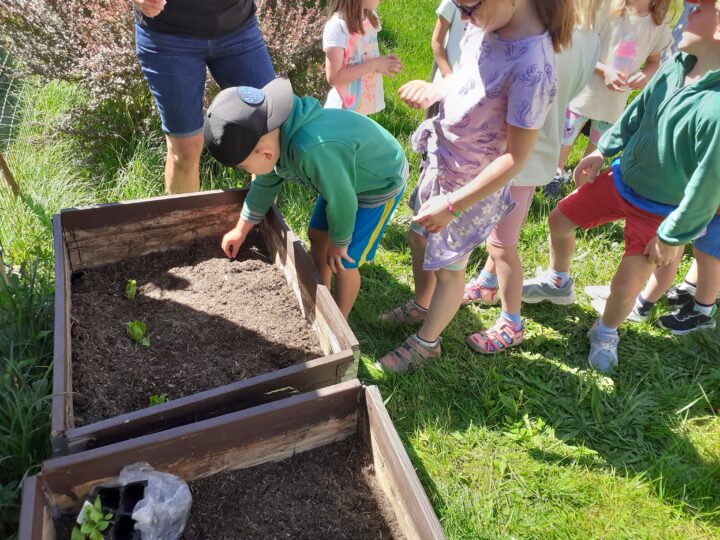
72, 233, 322, 425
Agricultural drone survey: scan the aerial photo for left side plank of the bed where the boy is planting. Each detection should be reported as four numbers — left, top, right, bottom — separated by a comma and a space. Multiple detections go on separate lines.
50, 214, 72, 452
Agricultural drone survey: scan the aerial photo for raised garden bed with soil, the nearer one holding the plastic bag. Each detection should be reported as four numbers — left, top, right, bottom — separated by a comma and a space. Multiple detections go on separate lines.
20, 380, 444, 540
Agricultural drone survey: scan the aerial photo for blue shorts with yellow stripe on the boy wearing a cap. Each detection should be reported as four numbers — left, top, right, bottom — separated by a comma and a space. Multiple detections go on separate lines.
310, 187, 405, 268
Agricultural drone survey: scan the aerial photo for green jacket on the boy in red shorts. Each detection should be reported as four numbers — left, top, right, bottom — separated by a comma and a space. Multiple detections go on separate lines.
598, 53, 720, 245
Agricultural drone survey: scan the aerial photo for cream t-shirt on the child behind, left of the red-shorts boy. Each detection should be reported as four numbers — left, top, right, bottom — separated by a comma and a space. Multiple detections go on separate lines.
570, 12, 672, 124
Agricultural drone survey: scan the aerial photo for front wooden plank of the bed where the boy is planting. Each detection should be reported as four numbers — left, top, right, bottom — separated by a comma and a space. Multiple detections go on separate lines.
66, 350, 357, 453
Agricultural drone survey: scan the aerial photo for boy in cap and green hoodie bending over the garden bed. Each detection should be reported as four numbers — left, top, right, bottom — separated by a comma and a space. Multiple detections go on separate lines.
204, 78, 408, 317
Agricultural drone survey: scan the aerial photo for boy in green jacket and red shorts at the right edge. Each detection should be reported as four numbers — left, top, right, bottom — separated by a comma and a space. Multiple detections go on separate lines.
523, 0, 720, 372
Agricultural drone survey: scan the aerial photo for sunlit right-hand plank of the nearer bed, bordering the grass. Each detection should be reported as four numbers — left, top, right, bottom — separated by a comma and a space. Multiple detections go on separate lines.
365, 386, 446, 540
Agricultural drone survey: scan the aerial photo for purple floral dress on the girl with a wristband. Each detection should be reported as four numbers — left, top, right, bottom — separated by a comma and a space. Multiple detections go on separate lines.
410, 25, 556, 270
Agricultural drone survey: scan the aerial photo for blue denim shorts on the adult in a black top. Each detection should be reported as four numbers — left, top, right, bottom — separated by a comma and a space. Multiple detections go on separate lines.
135, 17, 275, 137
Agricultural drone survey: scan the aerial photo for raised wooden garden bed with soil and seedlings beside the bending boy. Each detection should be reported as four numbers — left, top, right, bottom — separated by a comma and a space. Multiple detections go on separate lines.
51, 190, 358, 455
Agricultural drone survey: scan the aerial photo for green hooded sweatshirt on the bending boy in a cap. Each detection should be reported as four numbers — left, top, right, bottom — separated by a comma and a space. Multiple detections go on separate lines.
240, 96, 407, 246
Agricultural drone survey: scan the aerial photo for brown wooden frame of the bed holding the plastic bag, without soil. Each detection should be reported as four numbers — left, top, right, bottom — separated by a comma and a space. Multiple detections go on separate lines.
20, 380, 445, 540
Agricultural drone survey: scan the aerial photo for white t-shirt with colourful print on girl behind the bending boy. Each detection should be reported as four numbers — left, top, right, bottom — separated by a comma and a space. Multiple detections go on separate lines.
323, 13, 385, 114
